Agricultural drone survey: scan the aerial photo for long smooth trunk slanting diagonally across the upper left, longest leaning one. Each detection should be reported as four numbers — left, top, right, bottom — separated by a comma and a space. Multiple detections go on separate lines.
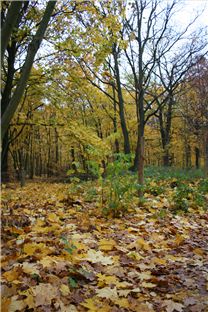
1, 1, 56, 138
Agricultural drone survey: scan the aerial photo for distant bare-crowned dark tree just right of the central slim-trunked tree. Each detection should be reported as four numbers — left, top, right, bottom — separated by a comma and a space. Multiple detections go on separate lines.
156, 37, 207, 166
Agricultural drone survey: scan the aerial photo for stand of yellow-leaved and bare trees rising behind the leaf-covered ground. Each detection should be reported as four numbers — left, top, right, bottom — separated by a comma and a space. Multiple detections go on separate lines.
1, 0, 208, 189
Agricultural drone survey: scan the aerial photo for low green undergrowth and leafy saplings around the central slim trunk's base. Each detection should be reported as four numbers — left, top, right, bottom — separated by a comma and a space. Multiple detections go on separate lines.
66, 158, 208, 217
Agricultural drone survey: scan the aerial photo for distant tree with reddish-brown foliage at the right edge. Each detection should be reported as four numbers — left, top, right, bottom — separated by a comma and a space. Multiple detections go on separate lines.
180, 55, 208, 175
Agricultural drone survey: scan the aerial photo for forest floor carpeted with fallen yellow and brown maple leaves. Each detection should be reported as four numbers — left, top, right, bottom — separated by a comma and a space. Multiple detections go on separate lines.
2, 182, 208, 312
